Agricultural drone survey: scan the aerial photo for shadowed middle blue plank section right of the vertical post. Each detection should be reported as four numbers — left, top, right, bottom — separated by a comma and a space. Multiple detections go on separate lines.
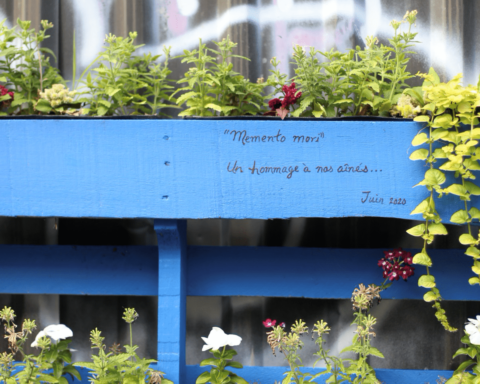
187, 247, 479, 301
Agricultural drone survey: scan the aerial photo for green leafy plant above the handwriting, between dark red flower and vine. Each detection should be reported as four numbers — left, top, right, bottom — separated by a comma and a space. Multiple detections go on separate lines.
269, 11, 421, 117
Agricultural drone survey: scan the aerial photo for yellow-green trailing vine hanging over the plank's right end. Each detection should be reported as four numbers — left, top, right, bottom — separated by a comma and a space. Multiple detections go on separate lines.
407, 69, 480, 331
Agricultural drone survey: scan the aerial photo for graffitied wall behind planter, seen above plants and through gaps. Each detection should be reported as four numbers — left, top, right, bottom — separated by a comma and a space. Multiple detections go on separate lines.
0, 0, 480, 376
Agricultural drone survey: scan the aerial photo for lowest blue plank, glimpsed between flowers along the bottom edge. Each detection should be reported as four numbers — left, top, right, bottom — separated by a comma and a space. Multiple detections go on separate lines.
187, 365, 453, 384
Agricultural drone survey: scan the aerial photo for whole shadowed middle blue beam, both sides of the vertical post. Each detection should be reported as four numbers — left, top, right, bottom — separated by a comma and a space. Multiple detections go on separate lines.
0, 245, 478, 300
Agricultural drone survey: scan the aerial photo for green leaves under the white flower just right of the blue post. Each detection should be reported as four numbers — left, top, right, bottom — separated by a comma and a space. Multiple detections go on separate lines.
195, 346, 247, 384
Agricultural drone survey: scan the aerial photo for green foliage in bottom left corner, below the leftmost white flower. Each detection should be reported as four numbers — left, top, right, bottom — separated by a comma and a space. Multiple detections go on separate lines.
0, 307, 80, 384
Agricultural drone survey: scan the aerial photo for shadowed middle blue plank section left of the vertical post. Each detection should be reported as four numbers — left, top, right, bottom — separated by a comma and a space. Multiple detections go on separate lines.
0, 245, 158, 295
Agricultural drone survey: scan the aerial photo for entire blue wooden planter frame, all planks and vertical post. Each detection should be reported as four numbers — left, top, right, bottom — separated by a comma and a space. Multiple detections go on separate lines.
0, 118, 472, 384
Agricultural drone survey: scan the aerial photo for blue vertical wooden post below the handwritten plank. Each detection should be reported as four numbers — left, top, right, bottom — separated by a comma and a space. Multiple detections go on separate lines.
154, 220, 187, 384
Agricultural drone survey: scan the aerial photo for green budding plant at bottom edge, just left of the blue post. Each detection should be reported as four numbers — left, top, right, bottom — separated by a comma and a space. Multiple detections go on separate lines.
74, 308, 173, 384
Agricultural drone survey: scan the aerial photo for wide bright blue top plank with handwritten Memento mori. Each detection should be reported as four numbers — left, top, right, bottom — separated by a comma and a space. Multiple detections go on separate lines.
0, 119, 468, 220
